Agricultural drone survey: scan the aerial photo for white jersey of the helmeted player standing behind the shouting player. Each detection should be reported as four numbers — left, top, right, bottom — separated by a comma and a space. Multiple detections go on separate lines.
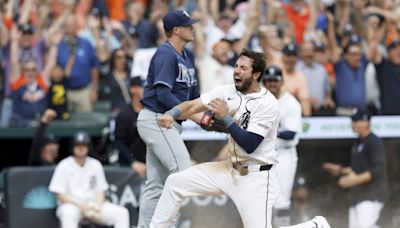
276, 92, 301, 149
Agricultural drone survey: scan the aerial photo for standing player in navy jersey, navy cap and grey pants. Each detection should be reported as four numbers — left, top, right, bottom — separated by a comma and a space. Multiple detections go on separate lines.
137, 11, 200, 228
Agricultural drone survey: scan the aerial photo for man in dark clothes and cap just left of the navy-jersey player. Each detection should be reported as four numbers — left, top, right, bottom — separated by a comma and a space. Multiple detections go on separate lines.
115, 77, 146, 177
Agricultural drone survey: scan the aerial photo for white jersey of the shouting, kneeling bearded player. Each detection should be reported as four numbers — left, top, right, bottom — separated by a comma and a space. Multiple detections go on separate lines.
200, 85, 279, 164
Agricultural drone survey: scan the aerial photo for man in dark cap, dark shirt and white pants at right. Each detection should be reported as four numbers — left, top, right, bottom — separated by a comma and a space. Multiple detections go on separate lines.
323, 110, 388, 228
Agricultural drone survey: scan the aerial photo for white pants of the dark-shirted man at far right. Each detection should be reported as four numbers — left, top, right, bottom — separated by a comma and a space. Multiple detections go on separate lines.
349, 201, 383, 228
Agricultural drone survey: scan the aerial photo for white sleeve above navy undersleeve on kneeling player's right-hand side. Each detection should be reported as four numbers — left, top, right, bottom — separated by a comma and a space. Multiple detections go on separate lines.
247, 101, 279, 137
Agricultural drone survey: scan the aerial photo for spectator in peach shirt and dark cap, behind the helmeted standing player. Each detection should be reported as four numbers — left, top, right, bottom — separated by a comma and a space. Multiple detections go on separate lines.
282, 43, 311, 116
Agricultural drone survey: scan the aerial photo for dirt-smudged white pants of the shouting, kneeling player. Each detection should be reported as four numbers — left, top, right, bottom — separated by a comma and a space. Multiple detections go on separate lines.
150, 161, 279, 228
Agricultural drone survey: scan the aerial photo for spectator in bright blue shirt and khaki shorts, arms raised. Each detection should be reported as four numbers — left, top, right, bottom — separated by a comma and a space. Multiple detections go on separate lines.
57, 15, 99, 112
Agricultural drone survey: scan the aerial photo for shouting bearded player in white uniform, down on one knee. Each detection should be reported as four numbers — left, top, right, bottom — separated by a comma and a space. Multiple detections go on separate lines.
150, 50, 279, 228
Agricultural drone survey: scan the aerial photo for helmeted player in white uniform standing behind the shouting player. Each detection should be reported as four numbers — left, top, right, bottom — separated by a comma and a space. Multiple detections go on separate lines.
263, 66, 301, 227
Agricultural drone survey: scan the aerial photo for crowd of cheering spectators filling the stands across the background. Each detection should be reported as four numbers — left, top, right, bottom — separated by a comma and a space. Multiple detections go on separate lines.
0, 0, 400, 126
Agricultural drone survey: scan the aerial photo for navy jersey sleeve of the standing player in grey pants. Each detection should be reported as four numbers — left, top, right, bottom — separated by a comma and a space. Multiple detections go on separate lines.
153, 51, 178, 89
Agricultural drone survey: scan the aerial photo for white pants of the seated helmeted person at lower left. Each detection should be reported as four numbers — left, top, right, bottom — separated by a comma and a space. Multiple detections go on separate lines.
56, 202, 130, 228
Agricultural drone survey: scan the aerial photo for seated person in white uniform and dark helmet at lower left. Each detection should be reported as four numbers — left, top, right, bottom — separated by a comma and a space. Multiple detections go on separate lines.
49, 132, 129, 228
